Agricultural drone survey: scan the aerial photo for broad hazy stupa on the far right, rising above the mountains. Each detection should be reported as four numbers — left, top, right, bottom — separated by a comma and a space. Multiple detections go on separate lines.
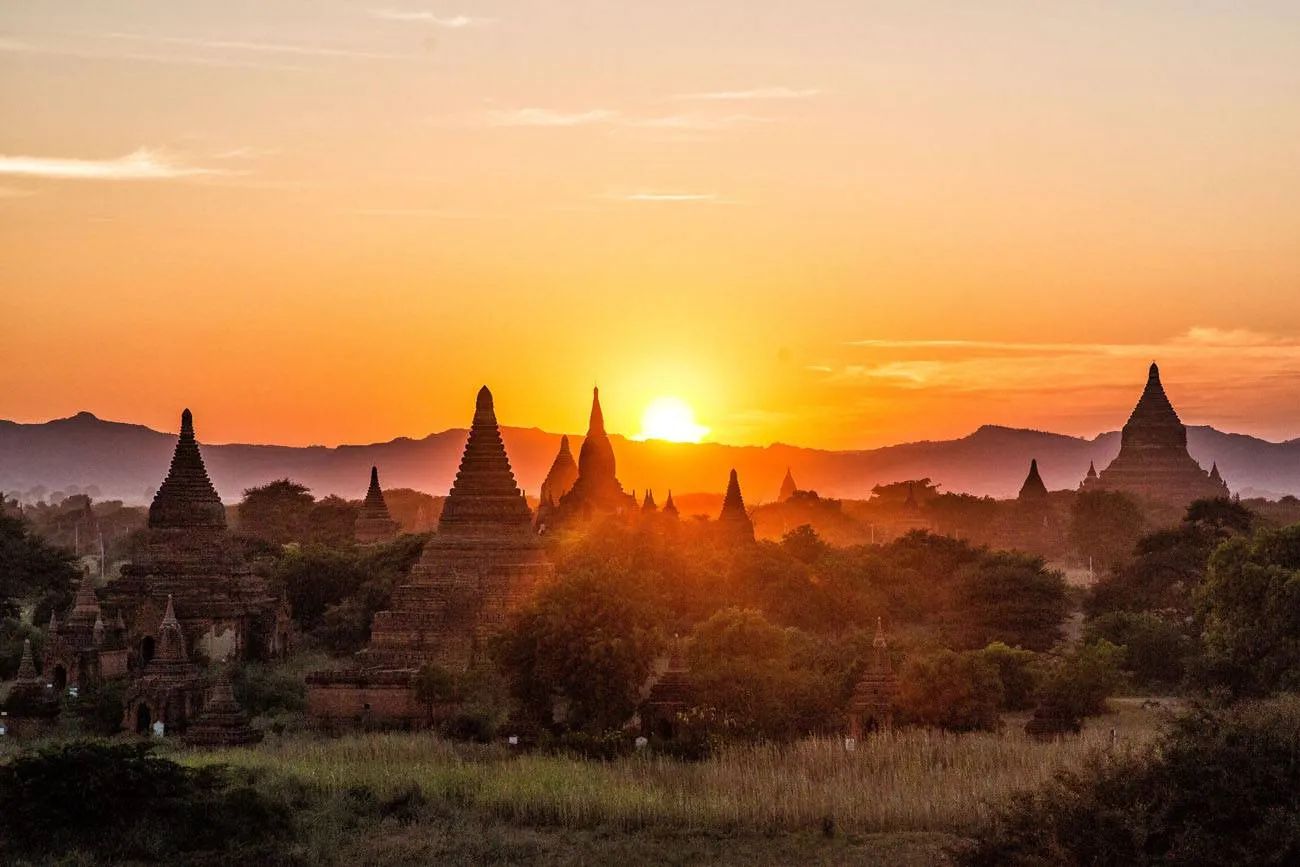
1083, 361, 1229, 506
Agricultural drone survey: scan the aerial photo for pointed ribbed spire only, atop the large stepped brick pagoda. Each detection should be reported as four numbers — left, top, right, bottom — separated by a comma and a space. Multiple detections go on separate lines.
438, 386, 533, 534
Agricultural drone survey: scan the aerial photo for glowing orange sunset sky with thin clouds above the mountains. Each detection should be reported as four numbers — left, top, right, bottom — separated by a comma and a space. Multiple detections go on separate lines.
0, 6, 1300, 447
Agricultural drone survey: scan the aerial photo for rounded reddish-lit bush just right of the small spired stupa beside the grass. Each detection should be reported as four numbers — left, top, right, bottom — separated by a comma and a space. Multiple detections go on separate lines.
897, 650, 1002, 732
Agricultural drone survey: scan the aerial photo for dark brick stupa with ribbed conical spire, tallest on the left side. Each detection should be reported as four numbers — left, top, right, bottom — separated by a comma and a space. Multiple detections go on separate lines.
107, 409, 290, 668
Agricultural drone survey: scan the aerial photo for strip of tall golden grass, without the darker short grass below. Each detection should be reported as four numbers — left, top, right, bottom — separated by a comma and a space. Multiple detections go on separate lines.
176, 701, 1167, 833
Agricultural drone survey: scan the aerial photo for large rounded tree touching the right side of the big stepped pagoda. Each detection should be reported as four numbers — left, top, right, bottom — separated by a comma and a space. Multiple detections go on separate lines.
493, 573, 659, 734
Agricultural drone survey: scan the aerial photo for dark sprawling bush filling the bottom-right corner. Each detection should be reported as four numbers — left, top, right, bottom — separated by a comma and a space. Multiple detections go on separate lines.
958, 697, 1300, 867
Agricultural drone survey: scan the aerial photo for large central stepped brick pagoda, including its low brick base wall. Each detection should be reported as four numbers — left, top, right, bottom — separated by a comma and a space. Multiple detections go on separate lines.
314, 386, 553, 725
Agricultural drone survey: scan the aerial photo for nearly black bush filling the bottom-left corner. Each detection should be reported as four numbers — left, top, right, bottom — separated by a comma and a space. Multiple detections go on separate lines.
0, 742, 294, 863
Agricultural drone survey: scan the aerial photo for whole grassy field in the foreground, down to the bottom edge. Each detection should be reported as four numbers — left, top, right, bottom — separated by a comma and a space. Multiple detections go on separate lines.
157, 701, 1167, 866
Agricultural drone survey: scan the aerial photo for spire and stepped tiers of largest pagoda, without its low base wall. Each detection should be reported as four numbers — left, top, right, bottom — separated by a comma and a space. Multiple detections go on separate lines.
360, 386, 551, 669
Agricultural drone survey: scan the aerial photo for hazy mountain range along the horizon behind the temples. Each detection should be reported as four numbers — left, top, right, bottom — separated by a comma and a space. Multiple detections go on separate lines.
0, 412, 1300, 503
